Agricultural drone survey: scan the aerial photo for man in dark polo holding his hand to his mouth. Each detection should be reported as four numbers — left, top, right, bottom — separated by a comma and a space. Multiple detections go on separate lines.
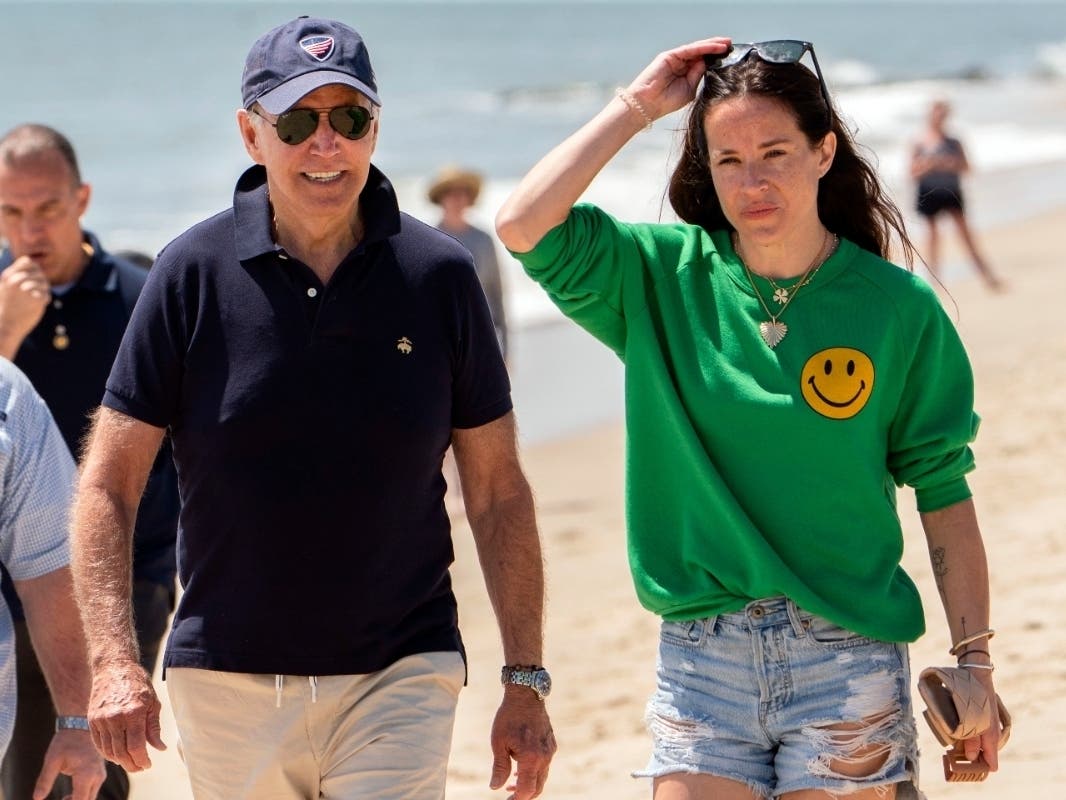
0, 125, 178, 800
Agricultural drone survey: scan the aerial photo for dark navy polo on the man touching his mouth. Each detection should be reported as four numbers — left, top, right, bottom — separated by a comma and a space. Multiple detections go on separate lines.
0, 237, 178, 614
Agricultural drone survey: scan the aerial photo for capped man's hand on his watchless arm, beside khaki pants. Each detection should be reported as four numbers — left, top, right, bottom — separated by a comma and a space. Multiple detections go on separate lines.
88, 662, 166, 772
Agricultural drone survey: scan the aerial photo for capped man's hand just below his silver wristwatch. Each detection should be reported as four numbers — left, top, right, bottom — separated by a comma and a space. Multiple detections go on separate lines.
488, 686, 556, 800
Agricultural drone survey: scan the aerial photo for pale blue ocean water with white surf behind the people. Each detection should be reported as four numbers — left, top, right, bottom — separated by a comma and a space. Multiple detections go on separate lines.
0, 0, 1066, 439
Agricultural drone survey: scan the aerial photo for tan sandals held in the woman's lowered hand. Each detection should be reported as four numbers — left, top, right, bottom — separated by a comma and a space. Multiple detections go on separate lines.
918, 667, 1011, 783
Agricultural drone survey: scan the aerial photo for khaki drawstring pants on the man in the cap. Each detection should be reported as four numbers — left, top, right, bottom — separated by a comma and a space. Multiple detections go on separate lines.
166, 653, 466, 800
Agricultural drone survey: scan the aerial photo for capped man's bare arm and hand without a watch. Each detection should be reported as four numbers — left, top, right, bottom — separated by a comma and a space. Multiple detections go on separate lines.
70, 406, 166, 772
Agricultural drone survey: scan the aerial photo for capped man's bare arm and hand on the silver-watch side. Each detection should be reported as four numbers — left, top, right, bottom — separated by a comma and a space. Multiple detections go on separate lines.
452, 413, 555, 800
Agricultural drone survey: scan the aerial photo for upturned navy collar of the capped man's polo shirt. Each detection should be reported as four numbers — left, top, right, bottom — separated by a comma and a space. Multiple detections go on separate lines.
233, 164, 400, 261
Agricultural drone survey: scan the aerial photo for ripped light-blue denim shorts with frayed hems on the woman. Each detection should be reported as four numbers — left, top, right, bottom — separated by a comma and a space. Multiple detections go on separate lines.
634, 597, 922, 800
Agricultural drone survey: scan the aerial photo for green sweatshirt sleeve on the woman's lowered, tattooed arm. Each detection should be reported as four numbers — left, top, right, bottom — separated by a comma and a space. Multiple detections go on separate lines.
888, 289, 981, 512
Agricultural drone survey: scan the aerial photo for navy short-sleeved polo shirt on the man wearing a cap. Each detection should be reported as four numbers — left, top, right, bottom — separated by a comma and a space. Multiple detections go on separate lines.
103, 166, 512, 675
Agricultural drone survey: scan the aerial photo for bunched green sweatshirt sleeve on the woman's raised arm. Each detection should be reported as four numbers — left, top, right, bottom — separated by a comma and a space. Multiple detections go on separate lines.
512, 204, 645, 357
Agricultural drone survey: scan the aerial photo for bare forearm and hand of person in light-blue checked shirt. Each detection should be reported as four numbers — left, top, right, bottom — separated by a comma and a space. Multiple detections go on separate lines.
15, 566, 107, 800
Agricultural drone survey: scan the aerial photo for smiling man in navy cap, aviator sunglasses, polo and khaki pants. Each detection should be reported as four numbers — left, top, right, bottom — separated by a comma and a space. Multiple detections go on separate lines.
74, 17, 555, 800
